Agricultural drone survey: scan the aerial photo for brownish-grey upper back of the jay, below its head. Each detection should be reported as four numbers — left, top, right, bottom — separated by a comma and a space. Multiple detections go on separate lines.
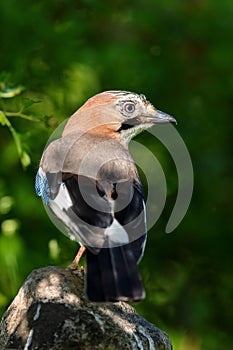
41, 134, 138, 182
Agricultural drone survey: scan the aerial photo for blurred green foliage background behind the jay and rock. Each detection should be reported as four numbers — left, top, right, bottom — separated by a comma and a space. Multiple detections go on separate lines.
0, 0, 233, 350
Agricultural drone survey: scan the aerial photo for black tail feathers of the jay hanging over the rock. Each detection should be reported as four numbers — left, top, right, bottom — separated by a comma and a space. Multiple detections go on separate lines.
86, 244, 145, 302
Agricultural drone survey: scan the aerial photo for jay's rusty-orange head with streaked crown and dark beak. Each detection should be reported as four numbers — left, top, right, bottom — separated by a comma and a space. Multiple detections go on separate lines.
63, 90, 176, 143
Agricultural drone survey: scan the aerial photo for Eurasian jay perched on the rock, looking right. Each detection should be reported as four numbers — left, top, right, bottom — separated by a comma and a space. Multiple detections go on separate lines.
36, 91, 175, 302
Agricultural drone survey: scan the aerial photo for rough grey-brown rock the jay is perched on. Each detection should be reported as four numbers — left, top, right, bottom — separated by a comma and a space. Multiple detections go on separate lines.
0, 266, 172, 350
